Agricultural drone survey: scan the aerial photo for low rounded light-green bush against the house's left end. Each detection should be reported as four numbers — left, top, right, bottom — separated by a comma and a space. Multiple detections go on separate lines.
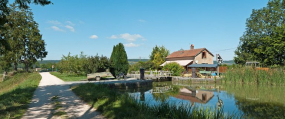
162, 62, 185, 76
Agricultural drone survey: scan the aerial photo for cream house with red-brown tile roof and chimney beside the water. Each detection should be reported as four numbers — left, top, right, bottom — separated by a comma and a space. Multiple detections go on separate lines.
160, 44, 214, 70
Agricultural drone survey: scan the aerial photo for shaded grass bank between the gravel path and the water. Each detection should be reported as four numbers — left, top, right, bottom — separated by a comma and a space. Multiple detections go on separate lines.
72, 84, 238, 119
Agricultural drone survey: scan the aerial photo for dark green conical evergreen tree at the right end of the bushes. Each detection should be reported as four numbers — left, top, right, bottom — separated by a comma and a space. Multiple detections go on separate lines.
110, 43, 129, 77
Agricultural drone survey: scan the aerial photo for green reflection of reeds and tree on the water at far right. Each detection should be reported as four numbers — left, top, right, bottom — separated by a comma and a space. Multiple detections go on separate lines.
225, 85, 285, 118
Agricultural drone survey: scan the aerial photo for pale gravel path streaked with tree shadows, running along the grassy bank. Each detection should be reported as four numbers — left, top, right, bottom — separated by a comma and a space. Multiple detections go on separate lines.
23, 72, 104, 119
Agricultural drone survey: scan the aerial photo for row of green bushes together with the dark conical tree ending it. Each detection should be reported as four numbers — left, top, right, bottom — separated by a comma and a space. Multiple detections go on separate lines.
55, 43, 129, 77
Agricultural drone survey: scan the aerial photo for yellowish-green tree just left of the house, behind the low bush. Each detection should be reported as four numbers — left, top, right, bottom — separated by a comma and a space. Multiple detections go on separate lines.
149, 46, 169, 69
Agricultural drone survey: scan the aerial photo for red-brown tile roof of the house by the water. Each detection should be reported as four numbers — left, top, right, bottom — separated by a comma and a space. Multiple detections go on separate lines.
166, 48, 214, 58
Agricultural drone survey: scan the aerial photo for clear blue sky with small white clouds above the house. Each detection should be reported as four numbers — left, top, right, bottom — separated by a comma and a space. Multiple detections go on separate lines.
26, 0, 268, 60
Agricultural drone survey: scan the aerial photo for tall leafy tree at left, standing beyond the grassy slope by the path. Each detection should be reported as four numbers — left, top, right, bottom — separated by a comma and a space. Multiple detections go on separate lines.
4, 4, 47, 71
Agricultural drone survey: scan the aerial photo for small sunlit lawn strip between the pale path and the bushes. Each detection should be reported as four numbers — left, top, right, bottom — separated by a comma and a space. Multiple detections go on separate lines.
50, 72, 87, 81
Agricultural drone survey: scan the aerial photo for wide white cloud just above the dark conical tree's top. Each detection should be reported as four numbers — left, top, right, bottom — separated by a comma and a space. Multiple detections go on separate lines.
110, 33, 143, 42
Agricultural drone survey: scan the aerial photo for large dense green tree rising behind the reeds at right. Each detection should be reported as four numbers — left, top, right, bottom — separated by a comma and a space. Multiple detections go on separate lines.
234, 0, 285, 65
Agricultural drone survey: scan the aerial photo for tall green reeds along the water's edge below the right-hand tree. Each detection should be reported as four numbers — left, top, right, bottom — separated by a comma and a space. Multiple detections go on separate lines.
223, 66, 285, 85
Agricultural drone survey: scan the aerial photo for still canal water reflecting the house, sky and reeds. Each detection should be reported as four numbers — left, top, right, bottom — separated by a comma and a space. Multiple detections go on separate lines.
120, 81, 285, 118
